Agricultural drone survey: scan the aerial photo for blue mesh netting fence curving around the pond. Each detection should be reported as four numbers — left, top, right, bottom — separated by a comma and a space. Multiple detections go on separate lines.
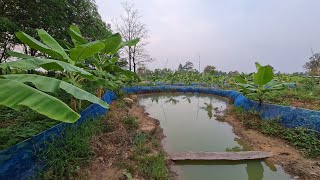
0, 83, 320, 180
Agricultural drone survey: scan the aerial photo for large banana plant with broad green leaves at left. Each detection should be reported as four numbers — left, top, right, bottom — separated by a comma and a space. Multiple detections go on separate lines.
0, 26, 135, 123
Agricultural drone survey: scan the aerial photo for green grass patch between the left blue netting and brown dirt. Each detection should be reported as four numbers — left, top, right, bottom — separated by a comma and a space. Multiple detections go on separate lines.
38, 119, 104, 179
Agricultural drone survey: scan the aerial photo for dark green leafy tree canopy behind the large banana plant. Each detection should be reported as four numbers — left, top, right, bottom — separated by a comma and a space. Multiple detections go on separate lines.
0, 0, 111, 56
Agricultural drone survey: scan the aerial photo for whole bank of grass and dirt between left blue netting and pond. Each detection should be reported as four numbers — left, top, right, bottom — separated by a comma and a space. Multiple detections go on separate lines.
37, 101, 169, 179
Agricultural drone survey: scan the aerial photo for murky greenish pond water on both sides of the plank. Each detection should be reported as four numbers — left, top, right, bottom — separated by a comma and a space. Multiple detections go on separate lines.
139, 93, 290, 180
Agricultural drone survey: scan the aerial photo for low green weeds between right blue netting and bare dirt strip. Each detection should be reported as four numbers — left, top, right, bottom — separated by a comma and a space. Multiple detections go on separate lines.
233, 108, 320, 158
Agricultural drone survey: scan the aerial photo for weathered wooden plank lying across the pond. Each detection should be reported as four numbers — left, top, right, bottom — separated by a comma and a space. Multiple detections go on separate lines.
169, 151, 272, 161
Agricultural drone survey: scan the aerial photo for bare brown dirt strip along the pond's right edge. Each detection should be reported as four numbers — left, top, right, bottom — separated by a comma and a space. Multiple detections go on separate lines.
224, 105, 320, 180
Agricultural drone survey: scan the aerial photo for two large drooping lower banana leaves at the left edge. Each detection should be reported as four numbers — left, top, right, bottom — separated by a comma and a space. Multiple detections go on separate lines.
0, 74, 109, 123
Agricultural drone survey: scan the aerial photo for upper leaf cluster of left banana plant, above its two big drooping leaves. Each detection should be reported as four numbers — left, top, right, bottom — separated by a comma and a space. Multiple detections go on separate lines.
7, 25, 139, 109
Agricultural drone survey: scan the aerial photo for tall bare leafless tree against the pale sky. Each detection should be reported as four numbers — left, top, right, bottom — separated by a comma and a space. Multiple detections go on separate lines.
112, 2, 153, 72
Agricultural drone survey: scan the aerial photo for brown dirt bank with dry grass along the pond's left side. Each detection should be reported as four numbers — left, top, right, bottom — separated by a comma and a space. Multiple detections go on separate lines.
79, 95, 175, 180
